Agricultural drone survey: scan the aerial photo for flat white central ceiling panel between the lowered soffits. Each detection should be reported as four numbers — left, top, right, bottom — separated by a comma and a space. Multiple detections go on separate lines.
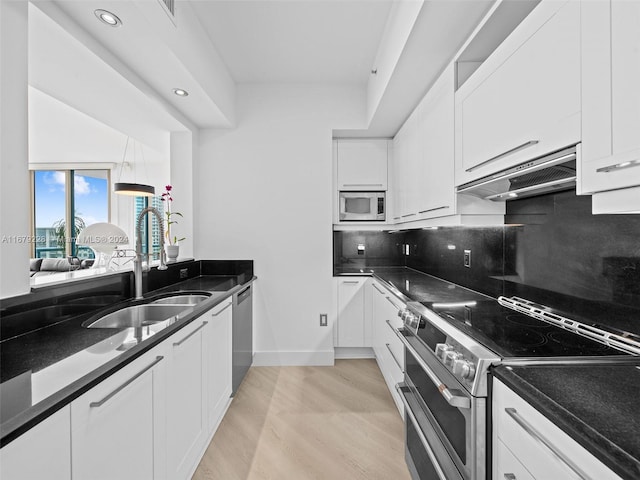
190, 0, 392, 84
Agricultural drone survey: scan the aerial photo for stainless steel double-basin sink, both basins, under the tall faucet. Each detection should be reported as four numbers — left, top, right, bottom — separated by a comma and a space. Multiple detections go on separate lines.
82, 292, 211, 328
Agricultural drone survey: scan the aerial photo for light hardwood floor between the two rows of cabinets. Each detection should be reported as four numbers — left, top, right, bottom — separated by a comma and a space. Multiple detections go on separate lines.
193, 359, 410, 480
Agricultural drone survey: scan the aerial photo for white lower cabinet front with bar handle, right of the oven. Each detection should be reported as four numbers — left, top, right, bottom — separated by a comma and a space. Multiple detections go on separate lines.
492, 379, 620, 480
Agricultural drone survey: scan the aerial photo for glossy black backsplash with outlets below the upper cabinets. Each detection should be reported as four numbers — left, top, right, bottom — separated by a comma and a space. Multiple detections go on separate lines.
334, 192, 640, 333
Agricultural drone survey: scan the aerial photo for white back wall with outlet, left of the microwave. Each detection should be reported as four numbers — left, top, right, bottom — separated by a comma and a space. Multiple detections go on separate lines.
194, 85, 366, 365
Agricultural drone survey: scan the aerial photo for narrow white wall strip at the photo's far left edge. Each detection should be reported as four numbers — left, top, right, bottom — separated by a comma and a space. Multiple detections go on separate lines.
0, 1, 30, 297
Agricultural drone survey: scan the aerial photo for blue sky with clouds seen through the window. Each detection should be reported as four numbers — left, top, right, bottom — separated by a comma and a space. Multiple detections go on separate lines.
35, 171, 109, 227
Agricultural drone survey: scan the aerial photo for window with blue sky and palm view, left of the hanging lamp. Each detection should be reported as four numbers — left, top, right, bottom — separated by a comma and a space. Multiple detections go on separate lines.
32, 170, 110, 258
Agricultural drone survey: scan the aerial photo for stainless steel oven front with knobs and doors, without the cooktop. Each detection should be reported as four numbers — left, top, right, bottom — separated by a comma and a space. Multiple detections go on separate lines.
396, 304, 499, 480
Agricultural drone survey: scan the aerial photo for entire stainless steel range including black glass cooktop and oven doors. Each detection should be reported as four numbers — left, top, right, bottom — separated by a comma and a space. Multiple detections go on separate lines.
388, 292, 640, 480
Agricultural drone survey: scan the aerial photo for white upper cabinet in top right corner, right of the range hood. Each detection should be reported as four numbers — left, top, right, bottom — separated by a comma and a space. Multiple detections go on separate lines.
579, 0, 640, 195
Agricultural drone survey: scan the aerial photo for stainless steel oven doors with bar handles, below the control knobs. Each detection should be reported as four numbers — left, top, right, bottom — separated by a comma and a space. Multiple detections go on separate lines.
390, 314, 496, 480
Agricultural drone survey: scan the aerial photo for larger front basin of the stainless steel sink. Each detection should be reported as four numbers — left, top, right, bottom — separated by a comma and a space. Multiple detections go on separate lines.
83, 304, 190, 328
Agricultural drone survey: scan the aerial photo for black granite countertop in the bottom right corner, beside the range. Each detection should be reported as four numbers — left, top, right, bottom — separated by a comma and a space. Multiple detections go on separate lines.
493, 359, 640, 480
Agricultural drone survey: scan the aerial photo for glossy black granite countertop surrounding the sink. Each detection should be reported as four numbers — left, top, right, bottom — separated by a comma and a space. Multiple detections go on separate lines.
0, 271, 255, 446
